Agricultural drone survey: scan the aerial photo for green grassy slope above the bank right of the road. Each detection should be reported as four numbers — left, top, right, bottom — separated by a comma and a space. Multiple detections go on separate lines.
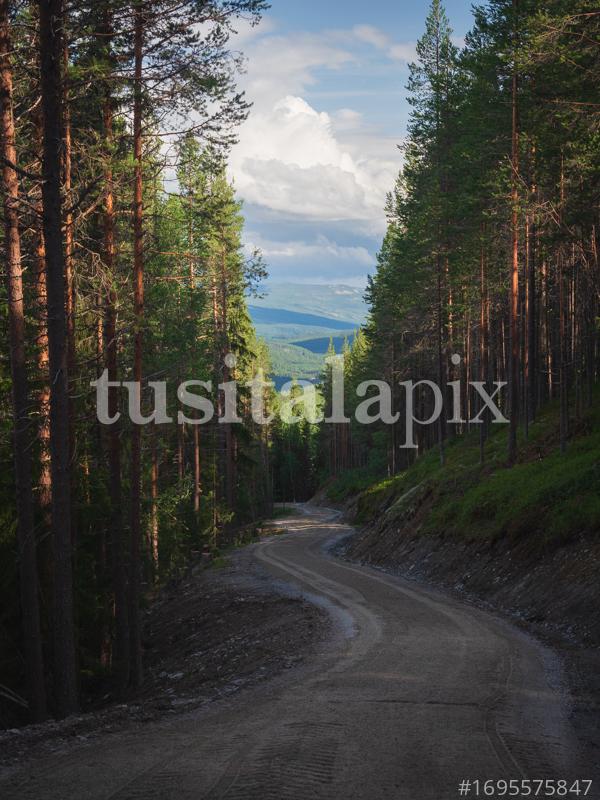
328, 398, 600, 547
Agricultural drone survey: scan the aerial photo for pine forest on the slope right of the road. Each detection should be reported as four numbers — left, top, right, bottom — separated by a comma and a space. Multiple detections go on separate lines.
316, 0, 600, 484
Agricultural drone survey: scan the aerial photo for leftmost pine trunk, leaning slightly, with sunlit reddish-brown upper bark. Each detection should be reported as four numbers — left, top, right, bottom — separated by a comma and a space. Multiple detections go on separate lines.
0, 0, 46, 721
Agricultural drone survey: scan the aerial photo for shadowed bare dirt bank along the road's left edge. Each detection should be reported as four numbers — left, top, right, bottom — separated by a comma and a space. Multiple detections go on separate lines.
0, 536, 327, 773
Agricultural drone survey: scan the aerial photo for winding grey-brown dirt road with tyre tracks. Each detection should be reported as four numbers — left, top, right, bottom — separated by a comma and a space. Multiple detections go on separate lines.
0, 506, 598, 800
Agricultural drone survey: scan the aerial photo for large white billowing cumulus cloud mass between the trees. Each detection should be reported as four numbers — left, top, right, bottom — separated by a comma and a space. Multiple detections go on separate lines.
230, 21, 412, 277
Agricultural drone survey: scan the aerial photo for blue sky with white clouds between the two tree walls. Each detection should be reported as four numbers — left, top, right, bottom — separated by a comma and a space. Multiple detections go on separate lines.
230, 0, 471, 286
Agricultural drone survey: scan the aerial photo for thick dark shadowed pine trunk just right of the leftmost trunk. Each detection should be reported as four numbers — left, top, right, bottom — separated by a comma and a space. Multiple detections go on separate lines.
38, 0, 78, 716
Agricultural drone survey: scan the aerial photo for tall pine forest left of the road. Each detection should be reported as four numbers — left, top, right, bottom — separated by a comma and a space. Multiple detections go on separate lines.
0, 0, 271, 720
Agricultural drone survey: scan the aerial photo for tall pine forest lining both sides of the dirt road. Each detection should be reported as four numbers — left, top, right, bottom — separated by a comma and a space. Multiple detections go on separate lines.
0, 0, 600, 736
